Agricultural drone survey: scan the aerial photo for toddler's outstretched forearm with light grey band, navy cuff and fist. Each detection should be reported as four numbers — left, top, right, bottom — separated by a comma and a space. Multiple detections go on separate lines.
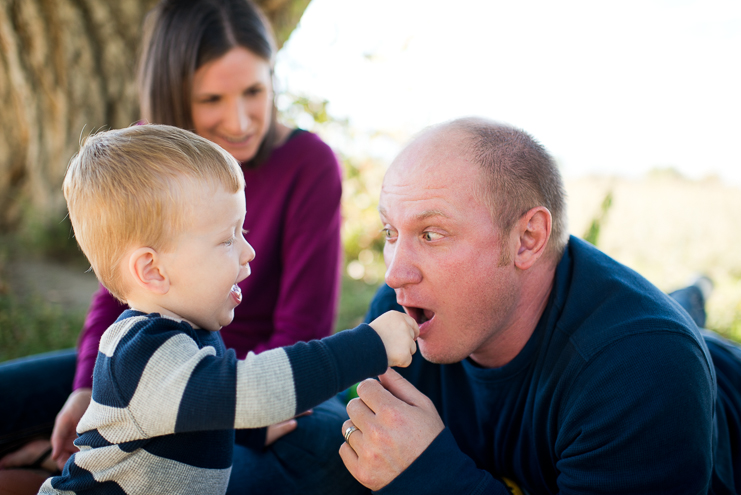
231, 312, 419, 428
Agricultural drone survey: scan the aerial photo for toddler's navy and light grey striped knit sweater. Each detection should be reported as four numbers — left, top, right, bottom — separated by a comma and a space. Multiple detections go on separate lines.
39, 310, 388, 495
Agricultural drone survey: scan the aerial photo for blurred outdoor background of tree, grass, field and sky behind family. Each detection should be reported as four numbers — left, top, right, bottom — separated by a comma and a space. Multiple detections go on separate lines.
0, 0, 741, 361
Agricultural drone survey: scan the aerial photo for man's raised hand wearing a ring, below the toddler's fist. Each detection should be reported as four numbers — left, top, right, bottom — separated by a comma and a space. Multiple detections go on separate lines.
340, 369, 445, 490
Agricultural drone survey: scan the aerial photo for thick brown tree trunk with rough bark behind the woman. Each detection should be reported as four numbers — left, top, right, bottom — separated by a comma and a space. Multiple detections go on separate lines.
0, 0, 310, 233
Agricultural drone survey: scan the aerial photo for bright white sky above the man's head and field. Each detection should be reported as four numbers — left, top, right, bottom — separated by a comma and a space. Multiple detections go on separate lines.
276, 0, 741, 185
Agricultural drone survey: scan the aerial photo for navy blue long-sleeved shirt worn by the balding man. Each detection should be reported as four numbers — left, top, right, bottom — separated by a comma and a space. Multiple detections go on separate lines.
368, 237, 741, 494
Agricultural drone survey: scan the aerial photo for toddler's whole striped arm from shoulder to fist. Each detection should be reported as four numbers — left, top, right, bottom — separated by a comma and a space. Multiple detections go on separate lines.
78, 313, 415, 441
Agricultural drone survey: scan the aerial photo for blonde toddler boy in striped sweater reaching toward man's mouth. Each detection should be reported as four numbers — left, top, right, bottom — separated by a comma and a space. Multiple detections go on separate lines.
40, 125, 419, 494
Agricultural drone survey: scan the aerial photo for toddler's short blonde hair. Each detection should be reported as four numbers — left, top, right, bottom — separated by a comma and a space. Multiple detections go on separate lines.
62, 124, 244, 301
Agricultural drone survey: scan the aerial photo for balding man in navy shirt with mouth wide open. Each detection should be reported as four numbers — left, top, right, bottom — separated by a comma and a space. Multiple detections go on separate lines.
340, 119, 741, 494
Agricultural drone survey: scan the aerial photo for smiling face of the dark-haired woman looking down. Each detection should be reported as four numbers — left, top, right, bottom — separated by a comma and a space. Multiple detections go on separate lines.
191, 47, 273, 162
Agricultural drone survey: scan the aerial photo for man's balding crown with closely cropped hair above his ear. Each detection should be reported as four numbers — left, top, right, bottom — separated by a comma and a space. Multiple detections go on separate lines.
390, 118, 568, 260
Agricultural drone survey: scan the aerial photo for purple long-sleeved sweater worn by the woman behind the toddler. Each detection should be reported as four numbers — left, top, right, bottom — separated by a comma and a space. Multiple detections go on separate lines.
74, 132, 342, 389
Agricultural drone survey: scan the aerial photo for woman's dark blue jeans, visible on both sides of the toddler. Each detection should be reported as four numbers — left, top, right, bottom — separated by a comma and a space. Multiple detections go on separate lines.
0, 349, 369, 495
